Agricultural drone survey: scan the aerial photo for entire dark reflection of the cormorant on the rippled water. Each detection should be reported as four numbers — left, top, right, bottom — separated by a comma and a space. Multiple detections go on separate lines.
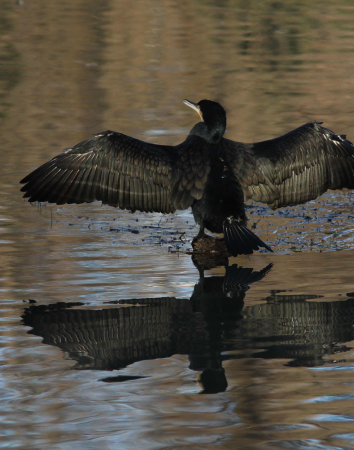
22, 264, 354, 393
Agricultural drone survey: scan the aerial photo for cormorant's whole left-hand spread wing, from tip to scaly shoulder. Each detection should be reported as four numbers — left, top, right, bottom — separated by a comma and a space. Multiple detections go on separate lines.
21, 131, 210, 213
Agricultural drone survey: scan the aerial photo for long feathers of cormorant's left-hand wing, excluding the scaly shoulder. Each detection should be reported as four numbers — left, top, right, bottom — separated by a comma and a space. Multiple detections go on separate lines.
21, 131, 175, 212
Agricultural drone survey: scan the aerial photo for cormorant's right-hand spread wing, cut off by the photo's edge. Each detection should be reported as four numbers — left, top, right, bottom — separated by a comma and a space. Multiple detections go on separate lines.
221, 122, 354, 209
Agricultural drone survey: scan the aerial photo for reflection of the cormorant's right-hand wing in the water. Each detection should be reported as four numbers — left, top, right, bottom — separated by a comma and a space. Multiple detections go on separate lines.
238, 293, 354, 367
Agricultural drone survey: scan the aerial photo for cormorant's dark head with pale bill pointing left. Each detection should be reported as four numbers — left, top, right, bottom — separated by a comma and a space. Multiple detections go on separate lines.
183, 100, 226, 144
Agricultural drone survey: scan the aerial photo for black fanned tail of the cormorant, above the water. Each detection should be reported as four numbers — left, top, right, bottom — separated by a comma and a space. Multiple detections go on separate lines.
224, 218, 273, 256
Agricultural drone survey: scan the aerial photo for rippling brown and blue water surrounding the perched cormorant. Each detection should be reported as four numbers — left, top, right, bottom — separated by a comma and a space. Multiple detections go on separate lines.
0, 0, 354, 450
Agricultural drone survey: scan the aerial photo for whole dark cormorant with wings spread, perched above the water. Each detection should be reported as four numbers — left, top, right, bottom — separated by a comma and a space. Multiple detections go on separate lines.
20, 99, 354, 256
